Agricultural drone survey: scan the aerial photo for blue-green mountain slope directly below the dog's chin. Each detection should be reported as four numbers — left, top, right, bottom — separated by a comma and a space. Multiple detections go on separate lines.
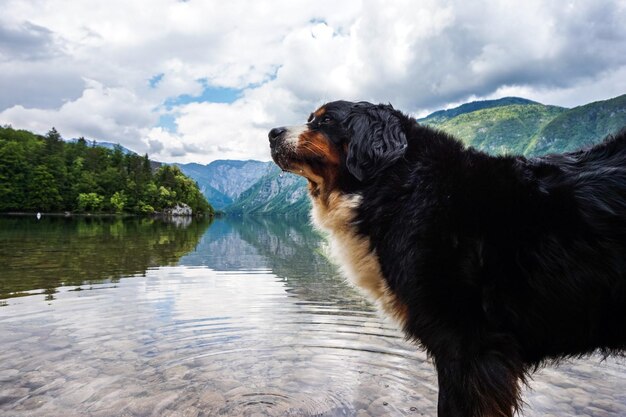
226, 164, 311, 216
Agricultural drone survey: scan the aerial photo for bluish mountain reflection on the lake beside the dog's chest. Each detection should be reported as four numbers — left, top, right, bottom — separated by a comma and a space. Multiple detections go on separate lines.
180, 218, 358, 308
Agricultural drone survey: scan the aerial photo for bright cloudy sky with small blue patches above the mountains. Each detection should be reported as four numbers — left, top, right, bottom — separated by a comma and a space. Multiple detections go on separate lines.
0, 0, 626, 164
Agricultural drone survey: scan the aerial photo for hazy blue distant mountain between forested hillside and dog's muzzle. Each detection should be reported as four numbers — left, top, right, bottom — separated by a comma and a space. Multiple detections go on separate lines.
177, 160, 271, 210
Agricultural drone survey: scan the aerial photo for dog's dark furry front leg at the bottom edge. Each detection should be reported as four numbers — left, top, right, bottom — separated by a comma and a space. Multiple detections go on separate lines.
435, 352, 524, 417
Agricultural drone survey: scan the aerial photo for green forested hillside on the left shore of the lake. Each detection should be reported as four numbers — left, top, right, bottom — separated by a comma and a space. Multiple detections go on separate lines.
0, 126, 213, 214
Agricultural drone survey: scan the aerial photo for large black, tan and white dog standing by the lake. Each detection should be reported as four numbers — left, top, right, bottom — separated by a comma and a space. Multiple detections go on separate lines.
269, 101, 626, 417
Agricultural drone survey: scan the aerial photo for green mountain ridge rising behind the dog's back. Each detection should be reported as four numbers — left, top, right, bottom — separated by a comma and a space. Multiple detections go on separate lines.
417, 95, 626, 156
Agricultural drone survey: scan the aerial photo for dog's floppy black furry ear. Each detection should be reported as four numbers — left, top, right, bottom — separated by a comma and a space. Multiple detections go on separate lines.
346, 103, 407, 181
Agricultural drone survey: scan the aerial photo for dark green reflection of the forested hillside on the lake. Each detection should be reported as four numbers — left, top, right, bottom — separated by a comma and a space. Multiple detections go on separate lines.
0, 217, 210, 300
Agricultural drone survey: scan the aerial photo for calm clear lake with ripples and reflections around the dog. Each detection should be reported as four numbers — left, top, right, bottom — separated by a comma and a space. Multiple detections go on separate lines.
0, 216, 626, 417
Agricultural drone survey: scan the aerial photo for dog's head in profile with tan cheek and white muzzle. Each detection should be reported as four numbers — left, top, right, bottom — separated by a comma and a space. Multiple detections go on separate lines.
269, 101, 407, 196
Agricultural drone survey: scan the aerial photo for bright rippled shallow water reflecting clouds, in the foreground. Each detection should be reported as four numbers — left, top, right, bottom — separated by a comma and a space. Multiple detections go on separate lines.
0, 267, 626, 417
